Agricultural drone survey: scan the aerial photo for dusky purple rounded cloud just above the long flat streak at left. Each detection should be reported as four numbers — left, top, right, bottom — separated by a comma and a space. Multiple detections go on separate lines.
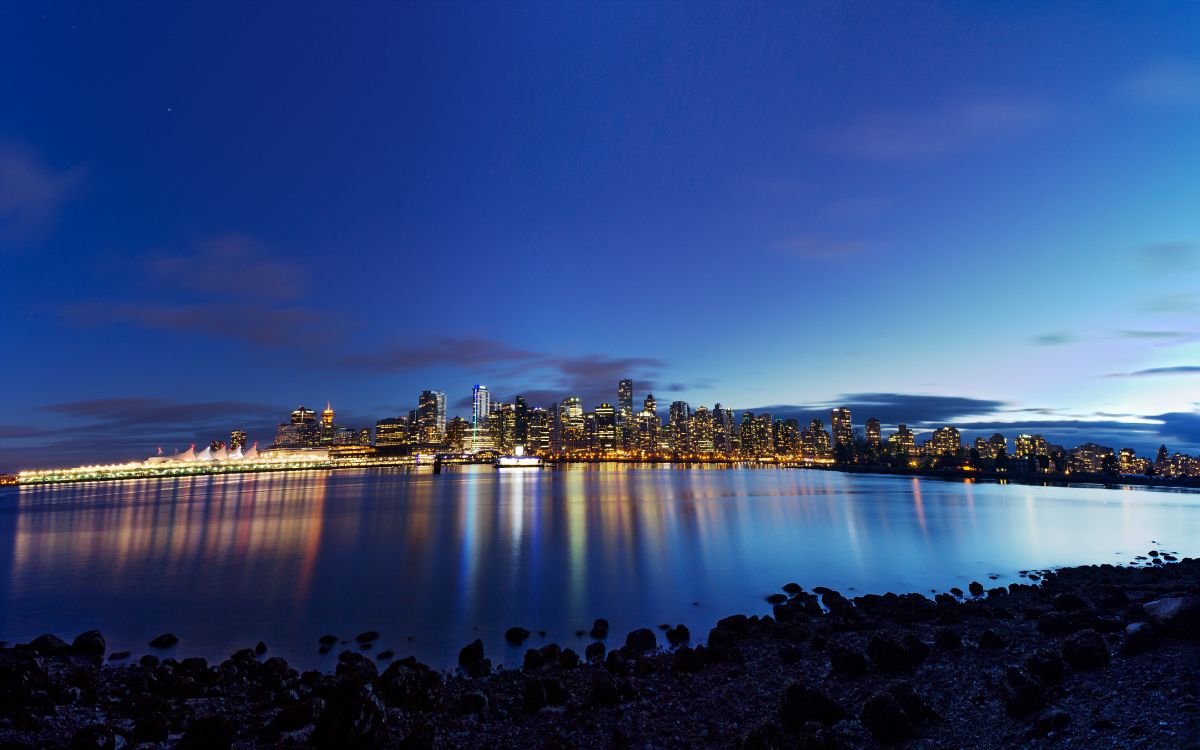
146, 234, 310, 300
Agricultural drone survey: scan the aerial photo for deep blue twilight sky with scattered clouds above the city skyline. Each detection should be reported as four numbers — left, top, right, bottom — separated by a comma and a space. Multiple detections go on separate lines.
0, 0, 1200, 470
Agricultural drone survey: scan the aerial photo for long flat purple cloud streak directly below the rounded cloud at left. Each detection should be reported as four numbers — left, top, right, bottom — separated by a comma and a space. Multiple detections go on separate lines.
62, 302, 338, 348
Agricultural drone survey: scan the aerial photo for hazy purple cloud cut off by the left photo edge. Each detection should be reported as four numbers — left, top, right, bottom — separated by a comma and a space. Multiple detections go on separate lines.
0, 144, 86, 247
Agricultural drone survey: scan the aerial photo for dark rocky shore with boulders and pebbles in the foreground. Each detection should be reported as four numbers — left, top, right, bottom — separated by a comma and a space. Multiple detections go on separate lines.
0, 551, 1200, 750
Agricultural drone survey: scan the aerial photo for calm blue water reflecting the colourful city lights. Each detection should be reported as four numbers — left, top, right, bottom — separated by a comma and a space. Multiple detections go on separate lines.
0, 467, 1200, 667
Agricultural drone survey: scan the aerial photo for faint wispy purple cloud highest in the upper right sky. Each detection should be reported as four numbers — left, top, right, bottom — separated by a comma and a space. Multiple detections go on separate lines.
816, 100, 1050, 162
